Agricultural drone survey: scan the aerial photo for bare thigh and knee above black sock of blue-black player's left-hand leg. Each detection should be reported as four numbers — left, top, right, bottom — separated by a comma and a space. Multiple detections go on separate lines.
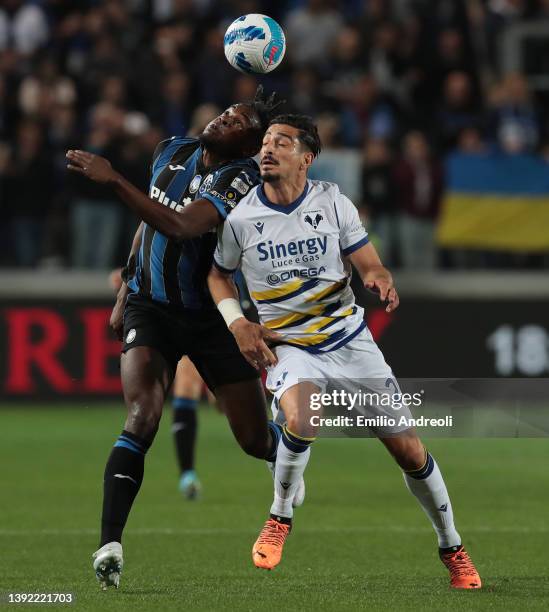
120, 346, 173, 438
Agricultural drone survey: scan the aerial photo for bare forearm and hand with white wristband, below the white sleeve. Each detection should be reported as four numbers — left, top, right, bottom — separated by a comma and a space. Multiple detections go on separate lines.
208, 266, 281, 369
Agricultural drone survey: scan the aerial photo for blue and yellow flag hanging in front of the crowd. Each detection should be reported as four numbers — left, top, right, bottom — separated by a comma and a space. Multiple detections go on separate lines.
437, 153, 549, 253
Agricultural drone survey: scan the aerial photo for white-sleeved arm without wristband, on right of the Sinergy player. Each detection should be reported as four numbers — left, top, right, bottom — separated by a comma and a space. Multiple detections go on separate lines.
334, 194, 399, 312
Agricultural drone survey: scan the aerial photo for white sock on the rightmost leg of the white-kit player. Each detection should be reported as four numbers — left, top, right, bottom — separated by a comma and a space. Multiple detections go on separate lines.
404, 453, 461, 548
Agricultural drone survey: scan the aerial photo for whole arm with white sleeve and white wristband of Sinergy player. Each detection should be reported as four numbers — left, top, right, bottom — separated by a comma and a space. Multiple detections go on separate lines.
208, 220, 281, 368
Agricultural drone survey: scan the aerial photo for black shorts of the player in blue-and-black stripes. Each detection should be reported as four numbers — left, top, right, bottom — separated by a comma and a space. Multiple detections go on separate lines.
122, 294, 259, 391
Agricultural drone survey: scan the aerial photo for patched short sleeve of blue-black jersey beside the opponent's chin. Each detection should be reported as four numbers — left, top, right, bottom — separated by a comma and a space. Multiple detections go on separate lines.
198, 166, 259, 219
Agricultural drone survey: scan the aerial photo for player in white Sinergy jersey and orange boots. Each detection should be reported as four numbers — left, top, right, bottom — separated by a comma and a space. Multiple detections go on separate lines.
208, 115, 481, 589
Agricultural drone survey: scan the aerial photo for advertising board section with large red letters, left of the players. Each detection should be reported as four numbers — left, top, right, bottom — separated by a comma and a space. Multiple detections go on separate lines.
0, 301, 121, 398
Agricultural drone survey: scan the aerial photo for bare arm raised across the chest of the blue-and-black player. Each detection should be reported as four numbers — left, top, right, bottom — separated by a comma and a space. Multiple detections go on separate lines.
67, 150, 221, 241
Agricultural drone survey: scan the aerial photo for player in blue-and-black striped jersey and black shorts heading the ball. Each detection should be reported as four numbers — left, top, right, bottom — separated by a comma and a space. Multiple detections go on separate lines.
67, 88, 280, 588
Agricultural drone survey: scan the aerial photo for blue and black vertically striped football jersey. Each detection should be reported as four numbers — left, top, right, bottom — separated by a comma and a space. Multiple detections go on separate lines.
128, 137, 259, 308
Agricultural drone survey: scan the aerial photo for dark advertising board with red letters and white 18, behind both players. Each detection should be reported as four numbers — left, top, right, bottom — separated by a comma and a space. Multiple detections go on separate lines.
0, 298, 549, 401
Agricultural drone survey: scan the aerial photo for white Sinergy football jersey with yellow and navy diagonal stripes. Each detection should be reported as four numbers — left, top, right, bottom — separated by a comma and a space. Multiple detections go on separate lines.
214, 180, 368, 353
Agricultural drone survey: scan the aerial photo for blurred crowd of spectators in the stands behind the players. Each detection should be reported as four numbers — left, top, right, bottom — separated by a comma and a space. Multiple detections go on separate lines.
0, 0, 549, 269
